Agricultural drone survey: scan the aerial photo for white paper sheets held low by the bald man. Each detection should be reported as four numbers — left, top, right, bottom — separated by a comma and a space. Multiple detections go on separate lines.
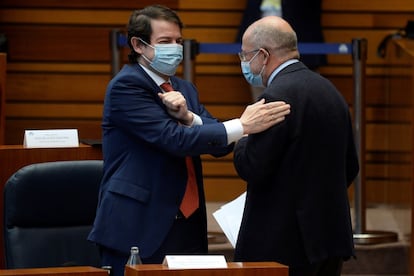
213, 192, 246, 248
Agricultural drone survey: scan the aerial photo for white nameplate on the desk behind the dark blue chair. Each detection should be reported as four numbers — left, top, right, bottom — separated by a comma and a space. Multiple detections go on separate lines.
23, 129, 79, 148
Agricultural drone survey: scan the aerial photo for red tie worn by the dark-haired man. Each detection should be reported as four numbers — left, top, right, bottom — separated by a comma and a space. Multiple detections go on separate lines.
161, 82, 199, 218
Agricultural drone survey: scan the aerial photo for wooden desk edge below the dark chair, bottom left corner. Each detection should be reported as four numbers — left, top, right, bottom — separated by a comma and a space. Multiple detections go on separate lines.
0, 266, 108, 276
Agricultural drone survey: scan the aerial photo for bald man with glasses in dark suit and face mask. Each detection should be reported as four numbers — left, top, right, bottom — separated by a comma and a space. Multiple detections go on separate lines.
234, 16, 359, 276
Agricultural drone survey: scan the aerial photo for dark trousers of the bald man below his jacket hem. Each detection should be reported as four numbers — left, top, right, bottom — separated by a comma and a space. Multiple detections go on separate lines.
289, 257, 343, 276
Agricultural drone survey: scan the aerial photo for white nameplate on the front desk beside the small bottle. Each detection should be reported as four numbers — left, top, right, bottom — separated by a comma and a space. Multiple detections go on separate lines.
163, 255, 227, 269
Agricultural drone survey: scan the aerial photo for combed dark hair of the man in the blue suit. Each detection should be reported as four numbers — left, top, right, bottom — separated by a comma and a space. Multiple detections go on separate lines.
127, 5, 183, 63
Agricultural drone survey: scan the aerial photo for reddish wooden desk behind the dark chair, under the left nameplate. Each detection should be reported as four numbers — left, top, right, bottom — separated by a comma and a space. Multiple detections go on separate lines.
0, 145, 102, 268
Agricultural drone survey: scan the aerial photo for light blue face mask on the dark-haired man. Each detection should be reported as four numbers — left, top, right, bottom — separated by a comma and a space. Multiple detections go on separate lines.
139, 39, 183, 76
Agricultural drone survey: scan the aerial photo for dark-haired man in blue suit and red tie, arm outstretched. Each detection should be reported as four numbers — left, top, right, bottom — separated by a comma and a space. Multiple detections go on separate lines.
88, 5, 290, 276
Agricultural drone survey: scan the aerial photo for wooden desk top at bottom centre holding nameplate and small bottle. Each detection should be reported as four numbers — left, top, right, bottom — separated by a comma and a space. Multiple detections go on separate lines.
125, 262, 289, 276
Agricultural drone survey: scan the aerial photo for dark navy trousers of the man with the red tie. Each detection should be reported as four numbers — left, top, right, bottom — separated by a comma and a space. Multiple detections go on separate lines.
100, 210, 208, 276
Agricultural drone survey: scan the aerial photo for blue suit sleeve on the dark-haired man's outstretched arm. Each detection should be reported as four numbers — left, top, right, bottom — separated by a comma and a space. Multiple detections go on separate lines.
106, 75, 233, 156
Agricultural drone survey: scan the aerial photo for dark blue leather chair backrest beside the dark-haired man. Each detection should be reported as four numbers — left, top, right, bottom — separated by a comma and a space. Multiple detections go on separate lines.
4, 160, 103, 268
